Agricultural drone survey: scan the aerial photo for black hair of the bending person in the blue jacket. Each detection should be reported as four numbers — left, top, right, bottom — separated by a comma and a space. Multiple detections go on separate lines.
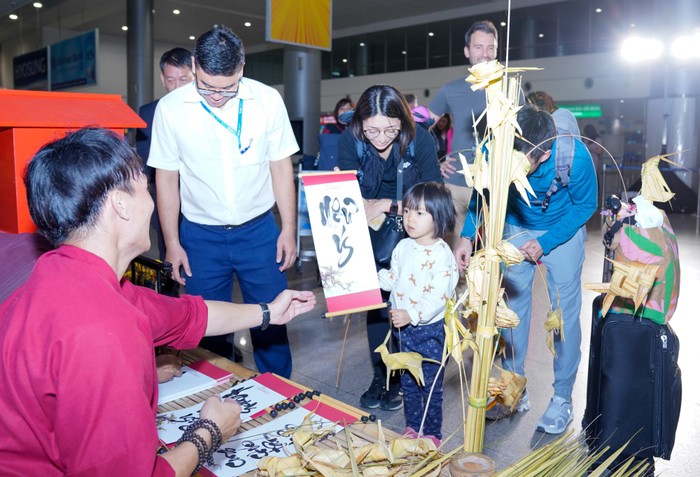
513, 104, 557, 162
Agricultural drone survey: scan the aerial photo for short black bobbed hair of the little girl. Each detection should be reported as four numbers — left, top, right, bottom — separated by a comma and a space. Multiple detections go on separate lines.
402, 182, 457, 239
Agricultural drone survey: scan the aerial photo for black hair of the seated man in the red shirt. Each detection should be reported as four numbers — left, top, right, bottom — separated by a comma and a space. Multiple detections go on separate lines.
24, 128, 143, 247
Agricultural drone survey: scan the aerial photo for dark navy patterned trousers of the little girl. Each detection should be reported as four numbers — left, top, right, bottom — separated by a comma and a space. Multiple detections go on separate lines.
394, 320, 445, 439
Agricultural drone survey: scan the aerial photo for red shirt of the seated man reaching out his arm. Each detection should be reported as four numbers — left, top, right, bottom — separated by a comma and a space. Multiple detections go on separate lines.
0, 246, 207, 477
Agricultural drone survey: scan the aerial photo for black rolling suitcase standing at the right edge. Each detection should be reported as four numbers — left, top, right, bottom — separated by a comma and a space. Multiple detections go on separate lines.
582, 295, 681, 464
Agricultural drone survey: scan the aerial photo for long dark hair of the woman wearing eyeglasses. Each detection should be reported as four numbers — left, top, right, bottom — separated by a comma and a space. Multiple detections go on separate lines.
348, 84, 416, 156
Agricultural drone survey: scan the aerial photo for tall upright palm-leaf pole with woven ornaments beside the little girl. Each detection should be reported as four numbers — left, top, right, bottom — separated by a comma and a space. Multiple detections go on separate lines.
464, 61, 531, 453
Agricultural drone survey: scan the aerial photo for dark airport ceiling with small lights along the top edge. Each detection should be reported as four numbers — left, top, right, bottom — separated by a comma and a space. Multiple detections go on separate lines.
0, 0, 506, 51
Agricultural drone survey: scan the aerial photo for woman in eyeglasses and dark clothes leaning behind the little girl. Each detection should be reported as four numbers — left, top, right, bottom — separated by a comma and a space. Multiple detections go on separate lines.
338, 85, 442, 411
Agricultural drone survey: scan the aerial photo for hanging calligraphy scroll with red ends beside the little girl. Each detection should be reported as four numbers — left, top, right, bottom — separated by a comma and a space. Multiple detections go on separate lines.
301, 171, 385, 316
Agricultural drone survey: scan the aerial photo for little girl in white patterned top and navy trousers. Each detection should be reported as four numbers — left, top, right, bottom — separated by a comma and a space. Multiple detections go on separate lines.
379, 182, 459, 446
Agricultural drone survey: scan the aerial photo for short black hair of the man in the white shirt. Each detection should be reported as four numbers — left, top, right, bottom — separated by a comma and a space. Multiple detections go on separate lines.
194, 25, 245, 76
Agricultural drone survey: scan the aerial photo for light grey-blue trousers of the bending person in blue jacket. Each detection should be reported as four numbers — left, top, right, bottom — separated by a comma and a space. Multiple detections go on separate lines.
502, 223, 585, 399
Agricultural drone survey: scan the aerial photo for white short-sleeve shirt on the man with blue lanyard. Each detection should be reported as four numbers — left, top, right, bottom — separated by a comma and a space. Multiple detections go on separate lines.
148, 78, 299, 225
